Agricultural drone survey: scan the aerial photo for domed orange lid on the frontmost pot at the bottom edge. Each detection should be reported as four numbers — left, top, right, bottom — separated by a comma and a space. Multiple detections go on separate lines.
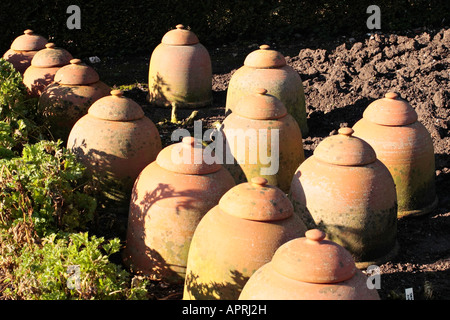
271, 229, 356, 283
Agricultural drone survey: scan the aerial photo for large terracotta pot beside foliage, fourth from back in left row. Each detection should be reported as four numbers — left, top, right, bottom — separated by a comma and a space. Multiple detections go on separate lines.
67, 90, 161, 205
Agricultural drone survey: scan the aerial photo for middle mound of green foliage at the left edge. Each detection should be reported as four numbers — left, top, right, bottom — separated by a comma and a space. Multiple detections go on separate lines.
0, 141, 96, 237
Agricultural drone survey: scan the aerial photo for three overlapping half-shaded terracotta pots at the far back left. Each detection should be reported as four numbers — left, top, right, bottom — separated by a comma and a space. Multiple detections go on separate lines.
3, 30, 111, 141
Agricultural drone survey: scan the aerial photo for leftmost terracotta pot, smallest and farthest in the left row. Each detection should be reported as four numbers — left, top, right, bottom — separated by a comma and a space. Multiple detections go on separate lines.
3, 29, 48, 75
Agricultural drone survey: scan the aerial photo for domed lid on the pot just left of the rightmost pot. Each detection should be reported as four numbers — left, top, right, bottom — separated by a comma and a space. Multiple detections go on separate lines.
314, 128, 377, 166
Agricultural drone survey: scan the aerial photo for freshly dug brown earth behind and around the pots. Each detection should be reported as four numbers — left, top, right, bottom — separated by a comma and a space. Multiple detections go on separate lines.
94, 28, 450, 300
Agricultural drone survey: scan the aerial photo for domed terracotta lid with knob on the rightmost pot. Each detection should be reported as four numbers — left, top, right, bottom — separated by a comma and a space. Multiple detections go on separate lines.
363, 92, 418, 126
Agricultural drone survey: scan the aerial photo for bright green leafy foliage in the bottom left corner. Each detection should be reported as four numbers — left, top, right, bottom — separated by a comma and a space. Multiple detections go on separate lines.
3, 233, 147, 300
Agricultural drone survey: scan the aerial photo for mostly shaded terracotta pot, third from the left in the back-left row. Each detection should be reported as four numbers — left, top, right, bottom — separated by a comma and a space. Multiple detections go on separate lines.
39, 59, 111, 141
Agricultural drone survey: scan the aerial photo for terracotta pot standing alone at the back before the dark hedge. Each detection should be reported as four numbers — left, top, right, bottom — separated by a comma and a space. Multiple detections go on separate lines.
148, 24, 212, 108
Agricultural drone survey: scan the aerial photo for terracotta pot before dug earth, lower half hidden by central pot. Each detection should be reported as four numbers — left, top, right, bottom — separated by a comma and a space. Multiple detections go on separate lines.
225, 45, 308, 137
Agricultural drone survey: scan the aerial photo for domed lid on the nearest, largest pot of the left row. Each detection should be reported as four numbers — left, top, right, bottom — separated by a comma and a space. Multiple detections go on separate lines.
88, 90, 144, 121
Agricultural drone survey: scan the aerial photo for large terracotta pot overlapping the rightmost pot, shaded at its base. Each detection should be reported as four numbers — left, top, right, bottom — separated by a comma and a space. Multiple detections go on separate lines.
290, 128, 398, 268
